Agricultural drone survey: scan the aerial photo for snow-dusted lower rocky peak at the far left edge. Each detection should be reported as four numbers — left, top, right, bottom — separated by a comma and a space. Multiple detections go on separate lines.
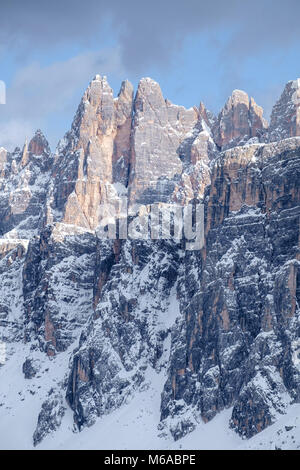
0, 130, 53, 239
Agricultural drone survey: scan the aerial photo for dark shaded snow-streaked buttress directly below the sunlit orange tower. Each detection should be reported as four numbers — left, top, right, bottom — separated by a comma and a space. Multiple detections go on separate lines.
22, 223, 96, 357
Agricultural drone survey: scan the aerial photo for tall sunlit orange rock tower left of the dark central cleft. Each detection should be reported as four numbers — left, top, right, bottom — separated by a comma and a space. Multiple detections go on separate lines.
49, 75, 133, 229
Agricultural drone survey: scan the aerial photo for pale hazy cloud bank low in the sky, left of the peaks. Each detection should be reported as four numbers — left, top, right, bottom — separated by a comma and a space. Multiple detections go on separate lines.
0, 48, 124, 149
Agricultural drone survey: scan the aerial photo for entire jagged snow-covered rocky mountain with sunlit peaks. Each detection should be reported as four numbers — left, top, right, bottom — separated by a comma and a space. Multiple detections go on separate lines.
0, 75, 300, 448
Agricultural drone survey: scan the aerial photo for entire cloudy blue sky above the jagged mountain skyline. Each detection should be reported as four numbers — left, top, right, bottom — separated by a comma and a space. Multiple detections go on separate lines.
0, 0, 300, 149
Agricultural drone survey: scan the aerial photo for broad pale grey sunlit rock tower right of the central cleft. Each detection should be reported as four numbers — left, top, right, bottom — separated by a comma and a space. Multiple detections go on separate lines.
129, 78, 198, 204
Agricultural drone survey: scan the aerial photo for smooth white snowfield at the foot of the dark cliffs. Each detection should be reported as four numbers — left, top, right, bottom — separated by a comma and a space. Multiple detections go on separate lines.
0, 343, 300, 450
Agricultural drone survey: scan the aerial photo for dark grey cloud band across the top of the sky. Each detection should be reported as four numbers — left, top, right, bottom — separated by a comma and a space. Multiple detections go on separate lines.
0, 0, 300, 72
